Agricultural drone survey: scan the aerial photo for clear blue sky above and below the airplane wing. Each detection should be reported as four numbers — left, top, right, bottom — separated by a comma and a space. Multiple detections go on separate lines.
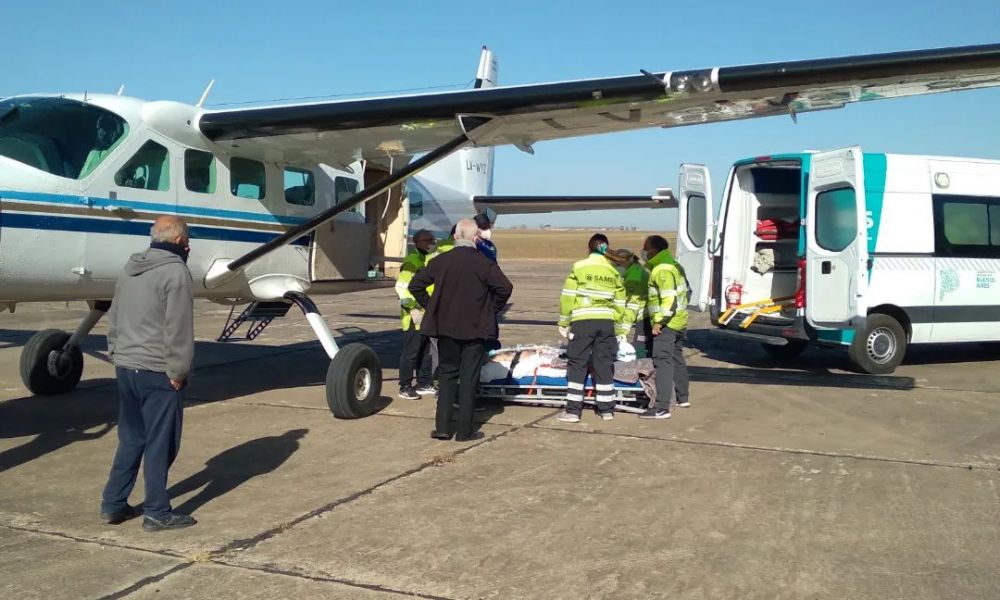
7, 0, 1000, 228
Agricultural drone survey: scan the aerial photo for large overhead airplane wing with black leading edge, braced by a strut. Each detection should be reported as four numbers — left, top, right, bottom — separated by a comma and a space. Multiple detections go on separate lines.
198, 44, 1000, 165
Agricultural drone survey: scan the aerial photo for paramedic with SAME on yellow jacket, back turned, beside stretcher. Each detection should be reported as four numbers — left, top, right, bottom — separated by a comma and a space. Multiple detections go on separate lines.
557, 233, 625, 423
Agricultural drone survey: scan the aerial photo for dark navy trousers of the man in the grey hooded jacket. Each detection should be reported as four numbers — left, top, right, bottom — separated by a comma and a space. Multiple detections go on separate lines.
101, 368, 184, 518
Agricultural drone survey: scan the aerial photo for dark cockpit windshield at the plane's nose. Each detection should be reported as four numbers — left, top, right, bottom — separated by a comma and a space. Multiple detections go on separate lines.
0, 97, 128, 179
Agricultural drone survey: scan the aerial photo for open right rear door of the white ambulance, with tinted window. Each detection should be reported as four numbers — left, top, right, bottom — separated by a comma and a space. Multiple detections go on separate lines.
806, 146, 868, 329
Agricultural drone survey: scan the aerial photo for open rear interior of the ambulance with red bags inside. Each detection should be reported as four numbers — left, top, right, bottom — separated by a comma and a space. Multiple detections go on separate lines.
721, 161, 802, 317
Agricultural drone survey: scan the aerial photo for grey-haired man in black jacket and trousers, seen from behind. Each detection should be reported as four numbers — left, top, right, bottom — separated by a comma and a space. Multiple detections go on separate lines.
409, 219, 513, 441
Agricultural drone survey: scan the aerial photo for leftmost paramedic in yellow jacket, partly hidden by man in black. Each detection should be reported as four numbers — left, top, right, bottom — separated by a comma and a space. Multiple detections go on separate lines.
396, 229, 437, 400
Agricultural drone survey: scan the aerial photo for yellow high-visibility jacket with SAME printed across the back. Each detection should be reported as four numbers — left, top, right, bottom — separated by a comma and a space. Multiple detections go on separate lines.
559, 252, 625, 334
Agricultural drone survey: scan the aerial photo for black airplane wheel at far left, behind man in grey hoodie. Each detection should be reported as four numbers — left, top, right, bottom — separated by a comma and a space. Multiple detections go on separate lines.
21, 329, 83, 396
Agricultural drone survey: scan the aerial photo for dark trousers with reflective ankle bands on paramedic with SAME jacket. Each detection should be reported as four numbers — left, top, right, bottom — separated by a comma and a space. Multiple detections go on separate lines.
566, 319, 618, 414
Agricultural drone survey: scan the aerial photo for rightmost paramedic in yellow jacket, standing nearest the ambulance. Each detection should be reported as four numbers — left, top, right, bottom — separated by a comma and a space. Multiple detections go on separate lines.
639, 235, 691, 419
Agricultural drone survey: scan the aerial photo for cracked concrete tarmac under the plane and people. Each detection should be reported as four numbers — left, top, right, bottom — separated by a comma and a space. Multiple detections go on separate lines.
0, 261, 1000, 600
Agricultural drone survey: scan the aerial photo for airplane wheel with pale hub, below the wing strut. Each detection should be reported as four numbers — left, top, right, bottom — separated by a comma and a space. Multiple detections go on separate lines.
326, 344, 382, 419
